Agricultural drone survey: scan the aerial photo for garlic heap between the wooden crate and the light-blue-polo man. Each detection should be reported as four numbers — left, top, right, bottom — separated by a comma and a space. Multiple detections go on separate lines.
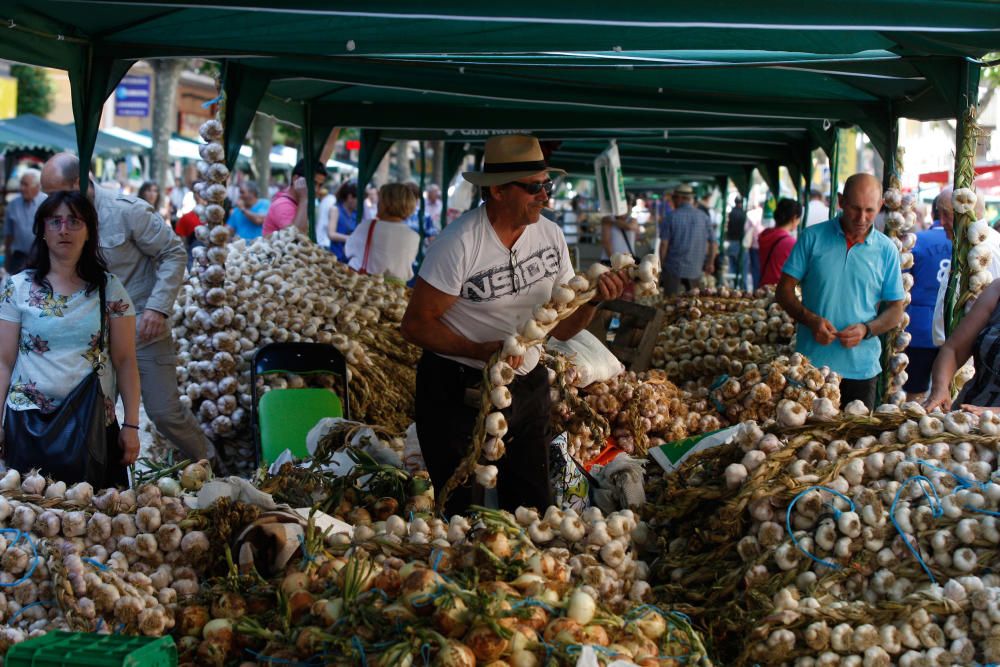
652, 288, 795, 384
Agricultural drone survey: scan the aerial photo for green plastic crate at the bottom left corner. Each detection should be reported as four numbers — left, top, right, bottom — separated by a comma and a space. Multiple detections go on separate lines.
3, 630, 177, 667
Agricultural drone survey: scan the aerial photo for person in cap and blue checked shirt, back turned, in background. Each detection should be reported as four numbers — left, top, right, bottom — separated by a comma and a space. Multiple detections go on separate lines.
660, 183, 716, 295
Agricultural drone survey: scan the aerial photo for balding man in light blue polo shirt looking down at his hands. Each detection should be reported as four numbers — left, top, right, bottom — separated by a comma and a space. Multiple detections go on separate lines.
776, 174, 906, 409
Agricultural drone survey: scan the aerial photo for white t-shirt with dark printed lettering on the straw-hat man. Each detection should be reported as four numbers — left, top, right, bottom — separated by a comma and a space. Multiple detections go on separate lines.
420, 205, 574, 375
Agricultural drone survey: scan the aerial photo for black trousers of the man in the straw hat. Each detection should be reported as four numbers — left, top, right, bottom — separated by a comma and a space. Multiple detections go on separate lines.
416, 352, 552, 516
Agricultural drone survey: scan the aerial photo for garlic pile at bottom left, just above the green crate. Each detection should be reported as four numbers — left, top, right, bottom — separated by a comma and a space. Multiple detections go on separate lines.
0, 462, 210, 653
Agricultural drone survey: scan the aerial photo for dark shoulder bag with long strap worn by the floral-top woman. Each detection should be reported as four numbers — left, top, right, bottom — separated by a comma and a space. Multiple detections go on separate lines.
3, 280, 114, 489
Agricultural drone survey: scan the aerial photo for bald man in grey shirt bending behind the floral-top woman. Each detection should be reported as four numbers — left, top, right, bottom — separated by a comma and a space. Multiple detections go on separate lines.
41, 153, 215, 463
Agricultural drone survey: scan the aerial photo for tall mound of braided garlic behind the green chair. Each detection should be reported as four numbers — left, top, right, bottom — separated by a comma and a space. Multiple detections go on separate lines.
174, 228, 417, 461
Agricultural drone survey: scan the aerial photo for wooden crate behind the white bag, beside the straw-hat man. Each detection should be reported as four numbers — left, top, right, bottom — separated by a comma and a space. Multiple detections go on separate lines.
587, 300, 665, 371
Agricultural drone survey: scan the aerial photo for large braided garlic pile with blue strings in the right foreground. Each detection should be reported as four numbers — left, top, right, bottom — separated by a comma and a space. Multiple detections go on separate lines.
647, 402, 1000, 667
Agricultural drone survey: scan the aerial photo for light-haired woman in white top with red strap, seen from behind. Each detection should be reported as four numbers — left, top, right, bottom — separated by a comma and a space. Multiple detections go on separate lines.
344, 183, 420, 283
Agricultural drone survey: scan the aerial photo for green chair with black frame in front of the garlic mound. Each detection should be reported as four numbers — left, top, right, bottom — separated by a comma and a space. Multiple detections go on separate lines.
250, 343, 350, 465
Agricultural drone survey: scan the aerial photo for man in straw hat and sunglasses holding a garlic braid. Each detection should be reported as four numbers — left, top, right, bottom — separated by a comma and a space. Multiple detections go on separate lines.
400, 135, 625, 514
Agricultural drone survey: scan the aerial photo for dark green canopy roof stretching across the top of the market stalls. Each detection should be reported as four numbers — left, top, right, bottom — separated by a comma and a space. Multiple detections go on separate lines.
0, 0, 1000, 196
